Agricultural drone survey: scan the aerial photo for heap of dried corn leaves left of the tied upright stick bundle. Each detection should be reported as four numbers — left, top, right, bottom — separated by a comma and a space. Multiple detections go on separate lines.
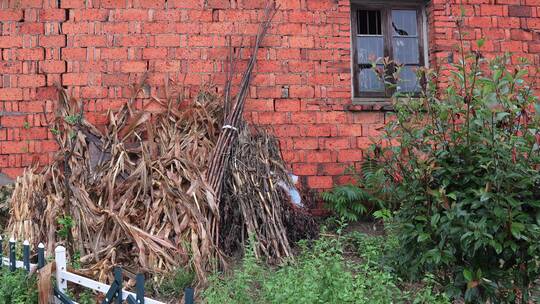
8, 84, 222, 281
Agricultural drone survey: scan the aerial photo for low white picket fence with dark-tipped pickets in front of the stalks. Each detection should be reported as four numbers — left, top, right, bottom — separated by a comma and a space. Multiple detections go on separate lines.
0, 237, 198, 304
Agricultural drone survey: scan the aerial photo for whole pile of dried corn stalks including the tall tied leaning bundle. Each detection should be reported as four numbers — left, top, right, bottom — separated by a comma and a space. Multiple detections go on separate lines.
7, 0, 312, 290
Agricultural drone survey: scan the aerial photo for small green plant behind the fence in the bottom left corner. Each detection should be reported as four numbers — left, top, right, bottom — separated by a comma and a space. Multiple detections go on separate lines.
0, 267, 38, 304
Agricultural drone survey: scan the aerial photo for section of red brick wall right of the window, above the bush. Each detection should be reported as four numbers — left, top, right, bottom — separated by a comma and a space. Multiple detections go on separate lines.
429, 0, 540, 88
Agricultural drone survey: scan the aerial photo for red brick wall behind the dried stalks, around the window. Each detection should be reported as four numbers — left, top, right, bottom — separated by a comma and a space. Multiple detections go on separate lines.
0, 0, 540, 196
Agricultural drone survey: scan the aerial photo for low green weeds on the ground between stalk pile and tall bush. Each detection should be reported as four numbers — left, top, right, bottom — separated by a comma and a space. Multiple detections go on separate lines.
203, 235, 449, 304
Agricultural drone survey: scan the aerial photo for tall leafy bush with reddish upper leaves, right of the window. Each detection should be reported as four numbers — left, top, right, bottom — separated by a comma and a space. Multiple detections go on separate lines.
364, 41, 540, 303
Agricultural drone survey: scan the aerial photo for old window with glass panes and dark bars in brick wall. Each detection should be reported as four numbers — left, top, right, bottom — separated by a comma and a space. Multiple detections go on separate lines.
351, 1, 426, 100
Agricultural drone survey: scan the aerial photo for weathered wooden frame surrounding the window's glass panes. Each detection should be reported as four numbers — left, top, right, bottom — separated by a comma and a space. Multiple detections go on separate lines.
351, 1, 427, 104
